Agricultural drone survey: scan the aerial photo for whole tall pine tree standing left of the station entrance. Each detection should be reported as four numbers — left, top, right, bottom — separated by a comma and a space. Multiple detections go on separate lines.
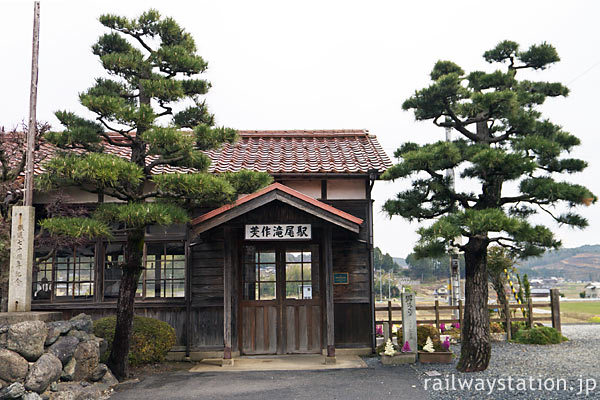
38, 10, 271, 379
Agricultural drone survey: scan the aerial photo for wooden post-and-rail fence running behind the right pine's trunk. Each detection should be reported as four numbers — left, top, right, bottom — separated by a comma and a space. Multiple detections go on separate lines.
375, 289, 561, 340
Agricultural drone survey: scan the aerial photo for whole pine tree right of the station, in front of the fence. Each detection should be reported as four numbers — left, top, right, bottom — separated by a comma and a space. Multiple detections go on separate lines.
384, 41, 596, 371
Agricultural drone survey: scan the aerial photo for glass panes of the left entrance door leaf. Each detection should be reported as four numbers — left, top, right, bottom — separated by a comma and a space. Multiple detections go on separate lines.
243, 250, 277, 300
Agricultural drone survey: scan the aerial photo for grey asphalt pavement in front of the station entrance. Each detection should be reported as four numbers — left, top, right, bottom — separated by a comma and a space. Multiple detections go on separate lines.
111, 359, 428, 400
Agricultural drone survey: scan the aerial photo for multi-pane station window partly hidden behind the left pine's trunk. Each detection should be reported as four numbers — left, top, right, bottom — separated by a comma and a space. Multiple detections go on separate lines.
104, 242, 185, 298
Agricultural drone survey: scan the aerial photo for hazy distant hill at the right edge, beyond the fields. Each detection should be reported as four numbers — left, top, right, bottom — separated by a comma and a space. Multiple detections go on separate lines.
518, 245, 600, 281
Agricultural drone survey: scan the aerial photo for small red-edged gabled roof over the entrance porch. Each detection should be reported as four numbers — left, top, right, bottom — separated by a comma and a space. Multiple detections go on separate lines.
191, 183, 363, 230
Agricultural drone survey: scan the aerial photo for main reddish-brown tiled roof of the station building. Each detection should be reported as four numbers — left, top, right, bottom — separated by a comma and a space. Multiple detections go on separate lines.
16, 130, 392, 174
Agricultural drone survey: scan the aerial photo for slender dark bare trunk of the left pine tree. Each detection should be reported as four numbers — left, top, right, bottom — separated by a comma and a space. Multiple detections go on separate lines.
108, 228, 144, 381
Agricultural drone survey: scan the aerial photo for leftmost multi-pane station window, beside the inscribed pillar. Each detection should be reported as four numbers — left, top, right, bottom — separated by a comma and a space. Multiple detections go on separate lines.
33, 246, 95, 300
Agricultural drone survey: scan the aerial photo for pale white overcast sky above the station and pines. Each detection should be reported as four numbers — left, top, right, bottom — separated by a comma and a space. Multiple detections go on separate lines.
0, 0, 600, 257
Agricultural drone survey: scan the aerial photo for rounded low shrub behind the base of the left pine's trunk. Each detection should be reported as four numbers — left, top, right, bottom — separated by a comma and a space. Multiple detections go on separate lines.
94, 316, 176, 366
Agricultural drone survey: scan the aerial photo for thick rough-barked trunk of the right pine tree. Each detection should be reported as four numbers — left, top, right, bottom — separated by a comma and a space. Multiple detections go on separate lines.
456, 237, 492, 372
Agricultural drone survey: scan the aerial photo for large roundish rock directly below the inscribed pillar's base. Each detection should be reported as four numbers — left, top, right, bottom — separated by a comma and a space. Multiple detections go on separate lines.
6, 321, 48, 361
